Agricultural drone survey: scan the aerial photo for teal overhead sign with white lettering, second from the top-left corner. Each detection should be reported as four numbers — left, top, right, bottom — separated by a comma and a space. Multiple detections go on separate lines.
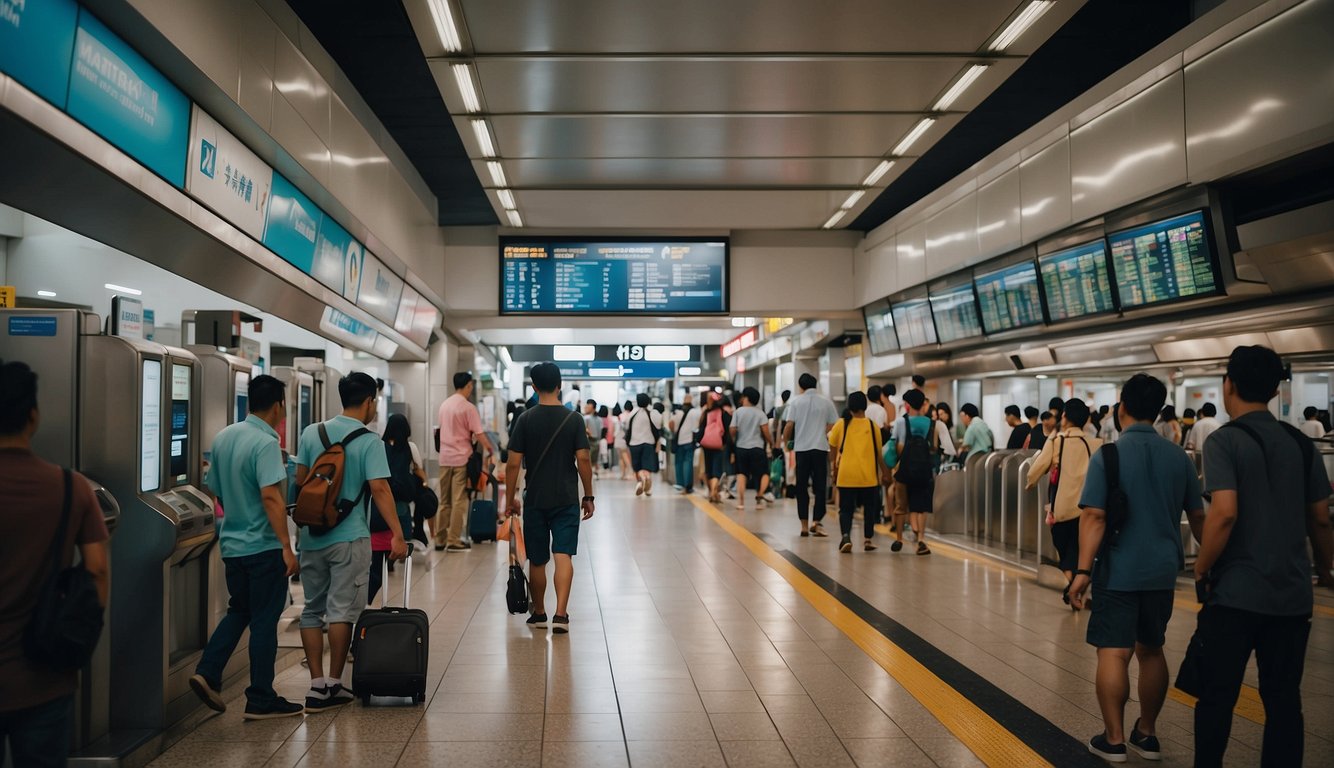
67, 11, 189, 189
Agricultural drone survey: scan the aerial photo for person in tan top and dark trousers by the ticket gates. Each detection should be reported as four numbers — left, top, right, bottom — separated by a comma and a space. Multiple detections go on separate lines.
1029, 400, 1102, 611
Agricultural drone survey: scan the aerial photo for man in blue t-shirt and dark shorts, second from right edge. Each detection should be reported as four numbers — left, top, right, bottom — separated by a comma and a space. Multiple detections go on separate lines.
1070, 373, 1203, 763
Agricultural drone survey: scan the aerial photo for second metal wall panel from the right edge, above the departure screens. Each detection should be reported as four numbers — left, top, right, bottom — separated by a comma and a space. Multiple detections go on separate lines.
1070, 71, 1186, 221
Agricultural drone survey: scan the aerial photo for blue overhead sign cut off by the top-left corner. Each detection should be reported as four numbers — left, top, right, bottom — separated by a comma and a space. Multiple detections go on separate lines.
0, 0, 79, 108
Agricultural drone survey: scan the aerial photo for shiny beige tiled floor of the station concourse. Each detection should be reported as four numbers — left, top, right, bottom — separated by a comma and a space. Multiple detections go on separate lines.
146, 480, 1334, 768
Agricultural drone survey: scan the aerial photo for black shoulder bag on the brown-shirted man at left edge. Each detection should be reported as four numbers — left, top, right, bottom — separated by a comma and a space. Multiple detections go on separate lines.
23, 469, 104, 669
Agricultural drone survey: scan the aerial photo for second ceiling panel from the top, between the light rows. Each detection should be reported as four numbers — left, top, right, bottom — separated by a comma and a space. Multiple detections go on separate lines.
464, 56, 1019, 113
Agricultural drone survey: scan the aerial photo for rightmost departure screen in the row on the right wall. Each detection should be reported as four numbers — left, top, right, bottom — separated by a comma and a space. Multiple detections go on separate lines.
1107, 211, 1222, 308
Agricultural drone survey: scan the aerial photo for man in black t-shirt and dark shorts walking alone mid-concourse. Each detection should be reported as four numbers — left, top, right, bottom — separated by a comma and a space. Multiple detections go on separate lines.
506, 363, 594, 635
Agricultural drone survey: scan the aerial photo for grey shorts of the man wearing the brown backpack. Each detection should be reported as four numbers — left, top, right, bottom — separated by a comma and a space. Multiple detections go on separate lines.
301, 539, 371, 629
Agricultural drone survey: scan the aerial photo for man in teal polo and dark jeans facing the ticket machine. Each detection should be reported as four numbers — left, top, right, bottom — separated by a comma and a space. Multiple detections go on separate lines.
189, 376, 303, 720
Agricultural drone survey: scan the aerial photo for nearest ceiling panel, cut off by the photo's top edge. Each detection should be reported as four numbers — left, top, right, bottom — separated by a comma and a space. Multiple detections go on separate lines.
462, 0, 1026, 53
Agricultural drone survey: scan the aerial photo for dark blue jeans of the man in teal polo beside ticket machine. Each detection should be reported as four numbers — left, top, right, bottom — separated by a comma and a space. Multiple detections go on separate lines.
195, 549, 287, 707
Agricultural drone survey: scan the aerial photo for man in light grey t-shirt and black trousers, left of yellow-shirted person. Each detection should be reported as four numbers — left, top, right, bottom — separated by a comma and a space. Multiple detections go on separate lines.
783, 373, 838, 537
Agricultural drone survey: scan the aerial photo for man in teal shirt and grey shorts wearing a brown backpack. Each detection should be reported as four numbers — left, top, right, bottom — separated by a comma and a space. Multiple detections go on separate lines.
296, 372, 405, 712
